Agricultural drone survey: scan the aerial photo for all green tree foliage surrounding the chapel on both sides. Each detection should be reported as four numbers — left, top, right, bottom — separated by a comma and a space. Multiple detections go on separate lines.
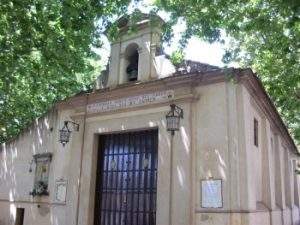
0, 0, 300, 146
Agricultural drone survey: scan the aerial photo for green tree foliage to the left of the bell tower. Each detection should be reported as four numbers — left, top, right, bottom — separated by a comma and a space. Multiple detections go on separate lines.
0, 0, 129, 143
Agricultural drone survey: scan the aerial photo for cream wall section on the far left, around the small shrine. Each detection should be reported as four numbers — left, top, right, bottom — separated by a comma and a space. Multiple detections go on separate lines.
0, 110, 78, 225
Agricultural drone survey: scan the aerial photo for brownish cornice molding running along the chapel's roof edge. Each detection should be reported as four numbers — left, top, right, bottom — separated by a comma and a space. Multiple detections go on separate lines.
55, 68, 300, 155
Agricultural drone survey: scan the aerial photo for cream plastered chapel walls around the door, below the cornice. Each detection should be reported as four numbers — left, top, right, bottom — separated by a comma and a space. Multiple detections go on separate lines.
0, 79, 299, 225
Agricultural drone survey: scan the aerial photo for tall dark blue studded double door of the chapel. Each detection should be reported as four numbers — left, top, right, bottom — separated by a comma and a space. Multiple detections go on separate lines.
94, 130, 158, 225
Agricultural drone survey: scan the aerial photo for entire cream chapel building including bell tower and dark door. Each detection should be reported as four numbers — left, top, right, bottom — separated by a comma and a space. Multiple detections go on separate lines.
0, 11, 300, 225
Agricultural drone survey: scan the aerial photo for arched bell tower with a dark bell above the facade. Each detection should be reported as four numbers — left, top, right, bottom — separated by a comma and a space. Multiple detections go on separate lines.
107, 11, 163, 87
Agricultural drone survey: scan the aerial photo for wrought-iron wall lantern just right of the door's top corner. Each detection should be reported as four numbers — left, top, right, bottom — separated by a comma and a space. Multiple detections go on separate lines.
166, 104, 183, 135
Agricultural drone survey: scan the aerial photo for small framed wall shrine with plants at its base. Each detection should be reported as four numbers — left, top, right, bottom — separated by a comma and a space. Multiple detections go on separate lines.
30, 153, 52, 196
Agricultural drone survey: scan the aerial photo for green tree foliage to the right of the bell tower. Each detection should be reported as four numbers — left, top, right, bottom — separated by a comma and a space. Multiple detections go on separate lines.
156, 0, 300, 143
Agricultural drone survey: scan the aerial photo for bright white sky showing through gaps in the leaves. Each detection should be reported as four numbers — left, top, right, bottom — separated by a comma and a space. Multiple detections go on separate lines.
96, 0, 237, 67
